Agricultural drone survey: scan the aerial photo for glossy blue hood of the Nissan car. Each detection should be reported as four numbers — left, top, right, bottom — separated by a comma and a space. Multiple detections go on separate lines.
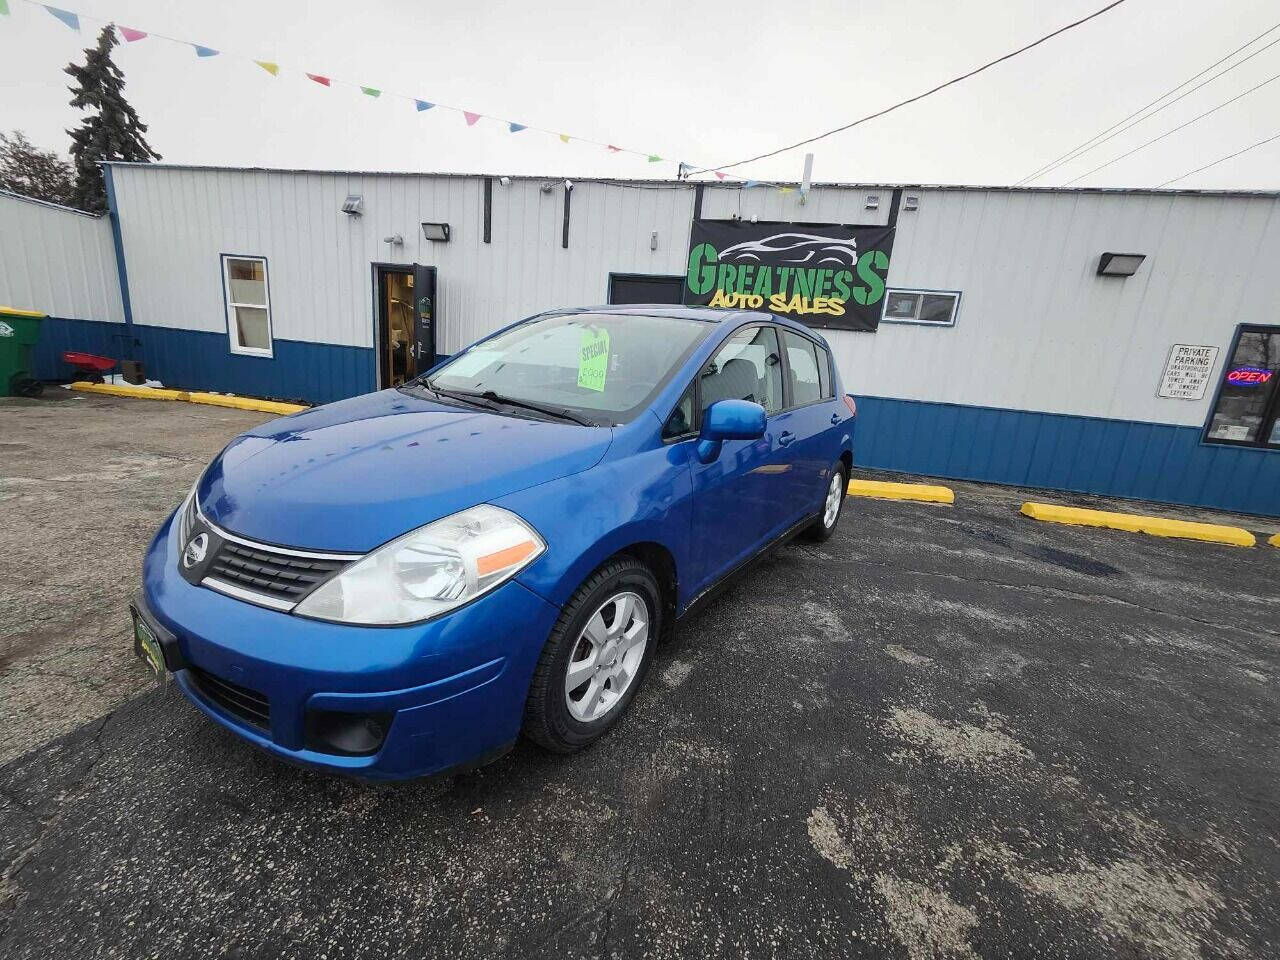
198, 390, 613, 552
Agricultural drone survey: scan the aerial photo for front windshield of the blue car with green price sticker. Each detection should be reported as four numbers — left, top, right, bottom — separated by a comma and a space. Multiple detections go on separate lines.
425, 314, 709, 422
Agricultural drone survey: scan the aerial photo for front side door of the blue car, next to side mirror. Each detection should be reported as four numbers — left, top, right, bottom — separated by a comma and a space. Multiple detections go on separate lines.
690, 324, 790, 591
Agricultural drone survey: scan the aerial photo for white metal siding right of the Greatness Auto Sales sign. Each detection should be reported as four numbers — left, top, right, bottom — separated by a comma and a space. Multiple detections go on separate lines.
828, 191, 1280, 426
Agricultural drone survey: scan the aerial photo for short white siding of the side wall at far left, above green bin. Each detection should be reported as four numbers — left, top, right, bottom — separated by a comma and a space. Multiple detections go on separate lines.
0, 193, 124, 323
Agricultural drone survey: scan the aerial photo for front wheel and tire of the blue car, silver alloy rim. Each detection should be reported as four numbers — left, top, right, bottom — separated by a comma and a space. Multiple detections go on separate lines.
524, 557, 663, 754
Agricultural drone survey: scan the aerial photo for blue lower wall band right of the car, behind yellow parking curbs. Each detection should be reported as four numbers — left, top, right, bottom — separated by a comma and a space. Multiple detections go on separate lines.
854, 397, 1280, 517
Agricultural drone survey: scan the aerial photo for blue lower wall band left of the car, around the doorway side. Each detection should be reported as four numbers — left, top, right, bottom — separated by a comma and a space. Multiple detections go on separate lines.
33, 317, 374, 403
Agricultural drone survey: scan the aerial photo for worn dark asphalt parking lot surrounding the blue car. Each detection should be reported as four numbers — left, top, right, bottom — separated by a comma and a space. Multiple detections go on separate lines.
0, 397, 1280, 960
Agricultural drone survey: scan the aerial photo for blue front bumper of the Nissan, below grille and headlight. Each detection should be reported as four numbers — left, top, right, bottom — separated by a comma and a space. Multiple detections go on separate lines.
138, 517, 559, 780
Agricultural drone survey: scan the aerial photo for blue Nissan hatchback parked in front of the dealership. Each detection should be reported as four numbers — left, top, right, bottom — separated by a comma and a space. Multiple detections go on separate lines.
133, 306, 855, 780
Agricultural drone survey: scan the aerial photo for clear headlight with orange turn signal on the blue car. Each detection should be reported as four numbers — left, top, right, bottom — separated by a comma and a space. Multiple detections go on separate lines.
293, 504, 547, 625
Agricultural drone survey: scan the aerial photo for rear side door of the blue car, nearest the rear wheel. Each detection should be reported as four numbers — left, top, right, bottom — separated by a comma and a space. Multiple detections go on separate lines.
781, 328, 844, 522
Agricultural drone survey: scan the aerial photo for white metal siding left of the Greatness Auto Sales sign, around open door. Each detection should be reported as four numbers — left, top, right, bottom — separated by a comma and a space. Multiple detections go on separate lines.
115, 166, 694, 353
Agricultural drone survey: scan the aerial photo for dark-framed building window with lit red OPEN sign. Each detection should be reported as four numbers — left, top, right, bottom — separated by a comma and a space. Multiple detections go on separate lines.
1204, 325, 1280, 449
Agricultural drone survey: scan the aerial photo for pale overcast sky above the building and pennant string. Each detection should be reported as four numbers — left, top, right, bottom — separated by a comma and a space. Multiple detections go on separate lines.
0, 0, 1280, 189
